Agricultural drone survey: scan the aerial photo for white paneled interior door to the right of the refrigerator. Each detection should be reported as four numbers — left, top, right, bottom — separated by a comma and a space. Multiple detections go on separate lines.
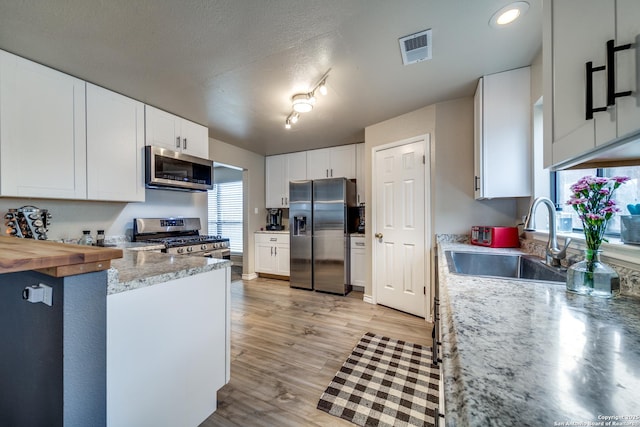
373, 137, 430, 317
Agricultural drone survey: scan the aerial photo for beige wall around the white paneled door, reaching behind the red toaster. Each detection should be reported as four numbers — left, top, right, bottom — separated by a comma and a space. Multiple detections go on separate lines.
365, 97, 516, 296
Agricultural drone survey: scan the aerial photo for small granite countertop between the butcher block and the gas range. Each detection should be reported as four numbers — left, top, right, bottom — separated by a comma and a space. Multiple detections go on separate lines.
107, 246, 231, 295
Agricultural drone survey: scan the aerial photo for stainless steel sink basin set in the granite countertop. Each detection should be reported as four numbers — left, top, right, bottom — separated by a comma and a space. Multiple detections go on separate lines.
445, 251, 567, 284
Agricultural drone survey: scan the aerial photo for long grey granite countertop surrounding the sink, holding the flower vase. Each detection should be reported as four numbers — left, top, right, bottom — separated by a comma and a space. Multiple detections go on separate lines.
438, 243, 640, 427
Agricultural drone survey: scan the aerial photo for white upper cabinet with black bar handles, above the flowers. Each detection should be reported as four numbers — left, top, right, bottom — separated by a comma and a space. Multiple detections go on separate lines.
543, 0, 640, 169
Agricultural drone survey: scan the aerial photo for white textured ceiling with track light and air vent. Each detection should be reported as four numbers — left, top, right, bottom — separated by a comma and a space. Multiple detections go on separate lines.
0, 0, 542, 154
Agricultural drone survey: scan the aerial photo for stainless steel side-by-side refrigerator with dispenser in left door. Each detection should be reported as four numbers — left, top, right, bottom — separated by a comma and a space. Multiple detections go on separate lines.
289, 178, 356, 295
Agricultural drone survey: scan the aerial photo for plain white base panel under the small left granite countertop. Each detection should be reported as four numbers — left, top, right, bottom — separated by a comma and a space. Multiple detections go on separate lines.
107, 267, 231, 427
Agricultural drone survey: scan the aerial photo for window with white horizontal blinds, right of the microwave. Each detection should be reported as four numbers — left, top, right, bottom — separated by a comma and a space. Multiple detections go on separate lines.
208, 181, 243, 254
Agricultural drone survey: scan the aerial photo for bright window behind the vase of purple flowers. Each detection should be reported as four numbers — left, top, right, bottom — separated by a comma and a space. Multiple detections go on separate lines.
552, 166, 640, 235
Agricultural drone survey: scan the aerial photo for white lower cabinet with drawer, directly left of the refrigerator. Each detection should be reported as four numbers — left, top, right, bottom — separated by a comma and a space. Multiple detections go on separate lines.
255, 233, 290, 276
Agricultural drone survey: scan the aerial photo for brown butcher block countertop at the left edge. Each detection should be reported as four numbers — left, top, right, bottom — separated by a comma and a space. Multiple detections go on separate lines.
0, 236, 122, 277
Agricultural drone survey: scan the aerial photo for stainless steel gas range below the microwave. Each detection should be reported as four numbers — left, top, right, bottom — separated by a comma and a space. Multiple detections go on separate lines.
132, 218, 231, 259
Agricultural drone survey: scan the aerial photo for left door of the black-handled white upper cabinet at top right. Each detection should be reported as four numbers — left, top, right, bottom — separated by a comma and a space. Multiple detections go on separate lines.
544, 0, 616, 166
